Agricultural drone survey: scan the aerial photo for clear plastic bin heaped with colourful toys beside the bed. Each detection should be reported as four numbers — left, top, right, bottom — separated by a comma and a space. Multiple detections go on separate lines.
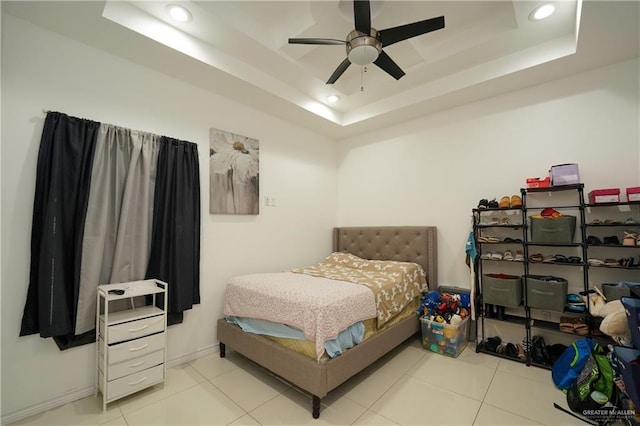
416, 291, 471, 357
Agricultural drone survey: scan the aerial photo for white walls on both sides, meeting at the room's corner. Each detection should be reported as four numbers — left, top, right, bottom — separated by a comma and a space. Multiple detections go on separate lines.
0, 6, 640, 422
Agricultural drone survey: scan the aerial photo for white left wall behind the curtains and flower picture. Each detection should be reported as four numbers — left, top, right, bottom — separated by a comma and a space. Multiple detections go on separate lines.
1, 15, 337, 423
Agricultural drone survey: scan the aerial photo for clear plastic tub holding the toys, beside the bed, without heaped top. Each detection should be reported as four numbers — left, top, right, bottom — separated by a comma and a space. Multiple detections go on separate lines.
420, 317, 469, 358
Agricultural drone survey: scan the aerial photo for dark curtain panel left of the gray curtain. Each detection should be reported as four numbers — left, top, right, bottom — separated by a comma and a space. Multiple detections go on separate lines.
20, 112, 100, 337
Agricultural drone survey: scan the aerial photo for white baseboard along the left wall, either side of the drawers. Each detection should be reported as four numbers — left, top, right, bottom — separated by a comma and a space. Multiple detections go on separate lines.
0, 345, 219, 425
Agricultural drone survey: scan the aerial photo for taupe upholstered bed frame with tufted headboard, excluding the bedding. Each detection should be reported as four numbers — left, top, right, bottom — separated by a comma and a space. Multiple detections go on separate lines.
217, 226, 438, 419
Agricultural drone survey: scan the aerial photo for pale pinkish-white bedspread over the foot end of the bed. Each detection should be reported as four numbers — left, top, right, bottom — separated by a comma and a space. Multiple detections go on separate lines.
224, 272, 377, 359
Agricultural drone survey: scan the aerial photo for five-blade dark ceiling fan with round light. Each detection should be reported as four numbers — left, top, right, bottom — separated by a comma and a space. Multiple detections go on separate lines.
289, 0, 444, 84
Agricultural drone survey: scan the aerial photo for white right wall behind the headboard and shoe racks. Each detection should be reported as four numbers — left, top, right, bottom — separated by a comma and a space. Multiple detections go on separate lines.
338, 59, 640, 287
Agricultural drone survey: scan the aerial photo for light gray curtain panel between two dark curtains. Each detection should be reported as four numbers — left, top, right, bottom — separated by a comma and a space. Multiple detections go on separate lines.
75, 124, 160, 335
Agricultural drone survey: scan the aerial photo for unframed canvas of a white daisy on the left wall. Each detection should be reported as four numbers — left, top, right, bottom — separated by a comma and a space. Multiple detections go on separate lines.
209, 128, 260, 214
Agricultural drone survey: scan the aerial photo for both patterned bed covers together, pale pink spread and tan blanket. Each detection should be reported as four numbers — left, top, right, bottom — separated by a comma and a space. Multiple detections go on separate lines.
224, 253, 426, 359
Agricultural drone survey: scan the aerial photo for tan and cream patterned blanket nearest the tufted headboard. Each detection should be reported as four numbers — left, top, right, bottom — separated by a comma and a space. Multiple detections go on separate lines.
291, 253, 426, 327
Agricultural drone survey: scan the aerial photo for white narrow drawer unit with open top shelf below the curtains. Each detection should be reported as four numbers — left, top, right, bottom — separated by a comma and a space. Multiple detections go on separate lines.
95, 279, 167, 410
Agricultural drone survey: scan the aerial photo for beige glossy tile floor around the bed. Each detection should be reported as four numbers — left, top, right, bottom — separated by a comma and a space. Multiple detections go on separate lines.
14, 338, 585, 426
